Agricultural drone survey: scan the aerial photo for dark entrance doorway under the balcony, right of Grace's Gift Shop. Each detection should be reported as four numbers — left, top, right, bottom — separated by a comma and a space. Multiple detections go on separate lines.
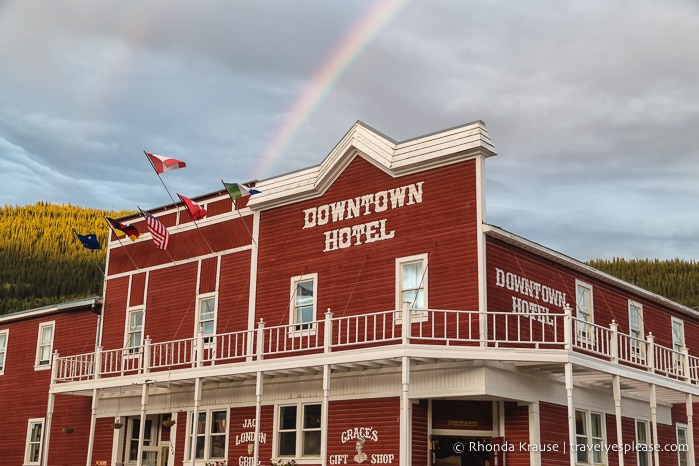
432, 435, 492, 466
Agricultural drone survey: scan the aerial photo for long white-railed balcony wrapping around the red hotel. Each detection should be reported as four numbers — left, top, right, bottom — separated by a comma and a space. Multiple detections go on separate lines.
52, 309, 699, 394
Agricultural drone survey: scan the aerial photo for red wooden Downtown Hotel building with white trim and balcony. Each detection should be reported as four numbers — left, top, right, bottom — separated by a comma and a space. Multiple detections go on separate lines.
5, 121, 699, 466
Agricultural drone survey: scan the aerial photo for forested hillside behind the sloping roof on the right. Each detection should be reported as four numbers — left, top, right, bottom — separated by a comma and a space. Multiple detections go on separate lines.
588, 258, 699, 308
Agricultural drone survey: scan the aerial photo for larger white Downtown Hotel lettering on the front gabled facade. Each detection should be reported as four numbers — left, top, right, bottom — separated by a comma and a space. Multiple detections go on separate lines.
303, 181, 424, 252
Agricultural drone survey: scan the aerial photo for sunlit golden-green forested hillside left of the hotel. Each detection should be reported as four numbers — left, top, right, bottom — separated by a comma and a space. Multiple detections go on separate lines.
0, 202, 133, 314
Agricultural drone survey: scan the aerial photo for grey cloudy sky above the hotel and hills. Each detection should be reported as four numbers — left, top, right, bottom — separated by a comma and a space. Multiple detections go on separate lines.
0, 0, 699, 260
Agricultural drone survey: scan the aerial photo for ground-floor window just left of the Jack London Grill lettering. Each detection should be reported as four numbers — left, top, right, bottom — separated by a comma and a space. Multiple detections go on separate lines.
186, 410, 228, 460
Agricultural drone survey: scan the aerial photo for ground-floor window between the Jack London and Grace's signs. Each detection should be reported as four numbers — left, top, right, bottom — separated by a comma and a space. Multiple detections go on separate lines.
277, 404, 321, 458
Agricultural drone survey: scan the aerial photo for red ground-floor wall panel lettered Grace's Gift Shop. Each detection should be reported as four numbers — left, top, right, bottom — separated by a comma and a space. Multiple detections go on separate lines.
328, 397, 400, 464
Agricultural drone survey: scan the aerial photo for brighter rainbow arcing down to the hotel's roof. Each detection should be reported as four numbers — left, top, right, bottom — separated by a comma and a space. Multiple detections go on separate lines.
254, 0, 409, 179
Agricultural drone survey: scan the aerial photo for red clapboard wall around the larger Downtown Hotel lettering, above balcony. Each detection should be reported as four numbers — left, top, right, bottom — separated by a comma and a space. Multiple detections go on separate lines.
256, 157, 478, 332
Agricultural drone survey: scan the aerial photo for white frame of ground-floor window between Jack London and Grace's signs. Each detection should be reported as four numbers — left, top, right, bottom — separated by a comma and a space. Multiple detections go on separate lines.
273, 400, 323, 461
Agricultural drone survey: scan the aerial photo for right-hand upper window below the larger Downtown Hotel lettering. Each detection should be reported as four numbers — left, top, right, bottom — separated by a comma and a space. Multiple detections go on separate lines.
396, 254, 427, 311
